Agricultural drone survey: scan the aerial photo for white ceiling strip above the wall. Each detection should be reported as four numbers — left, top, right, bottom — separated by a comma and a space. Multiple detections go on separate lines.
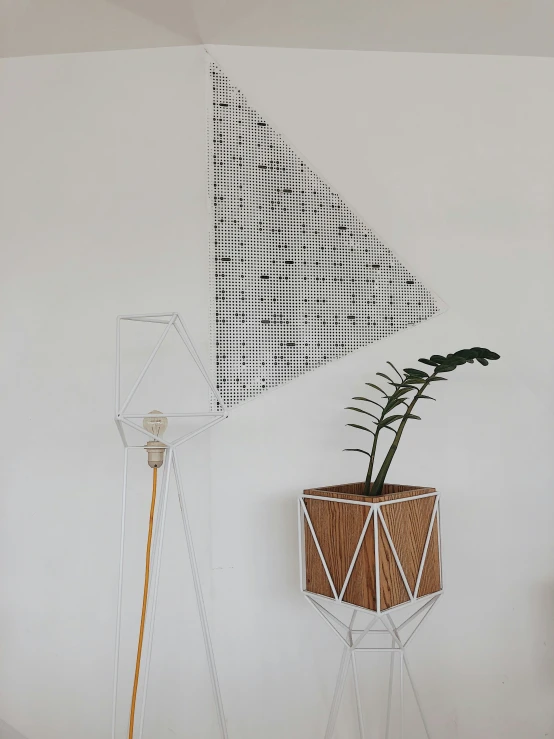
0, 0, 554, 56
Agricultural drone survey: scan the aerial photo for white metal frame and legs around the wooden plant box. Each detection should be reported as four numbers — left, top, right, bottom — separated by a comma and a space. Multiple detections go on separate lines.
298, 492, 443, 739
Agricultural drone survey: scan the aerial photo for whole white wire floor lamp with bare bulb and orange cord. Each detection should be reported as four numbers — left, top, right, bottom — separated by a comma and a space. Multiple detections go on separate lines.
112, 313, 228, 739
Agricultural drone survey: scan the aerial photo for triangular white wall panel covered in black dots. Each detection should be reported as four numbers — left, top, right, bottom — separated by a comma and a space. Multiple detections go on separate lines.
208, 63, 439, 407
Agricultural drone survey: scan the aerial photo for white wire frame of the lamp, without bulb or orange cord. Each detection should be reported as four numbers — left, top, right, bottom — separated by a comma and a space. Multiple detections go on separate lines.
111, 313, 229, 739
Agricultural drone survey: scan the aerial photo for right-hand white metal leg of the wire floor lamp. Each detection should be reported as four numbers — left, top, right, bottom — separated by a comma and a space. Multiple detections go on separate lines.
172, 456, 229, 739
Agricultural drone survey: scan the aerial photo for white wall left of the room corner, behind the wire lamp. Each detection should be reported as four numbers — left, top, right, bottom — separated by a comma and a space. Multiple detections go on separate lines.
0, 48, 220, 739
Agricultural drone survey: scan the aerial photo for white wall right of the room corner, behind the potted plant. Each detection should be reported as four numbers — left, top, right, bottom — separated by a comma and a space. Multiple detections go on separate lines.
205, 47, 554, 739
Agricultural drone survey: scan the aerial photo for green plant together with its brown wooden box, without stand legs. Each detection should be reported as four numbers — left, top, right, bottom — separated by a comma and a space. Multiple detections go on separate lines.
301, 347, 500, 613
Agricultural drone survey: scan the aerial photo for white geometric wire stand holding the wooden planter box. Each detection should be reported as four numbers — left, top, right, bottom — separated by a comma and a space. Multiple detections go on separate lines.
298, 490, 443, 739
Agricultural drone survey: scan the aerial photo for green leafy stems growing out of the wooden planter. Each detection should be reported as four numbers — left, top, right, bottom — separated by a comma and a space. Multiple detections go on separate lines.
344, 346, 500, 496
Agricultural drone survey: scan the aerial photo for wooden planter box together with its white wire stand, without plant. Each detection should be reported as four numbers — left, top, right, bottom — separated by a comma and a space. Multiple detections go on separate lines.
298, 483, 442, 739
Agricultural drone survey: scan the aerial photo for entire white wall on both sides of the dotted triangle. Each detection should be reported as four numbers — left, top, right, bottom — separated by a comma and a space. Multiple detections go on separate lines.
0, 47, 554, 739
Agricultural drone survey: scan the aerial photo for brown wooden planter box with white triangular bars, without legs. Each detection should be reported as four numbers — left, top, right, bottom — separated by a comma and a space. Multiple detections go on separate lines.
300, 483, 442, 613
